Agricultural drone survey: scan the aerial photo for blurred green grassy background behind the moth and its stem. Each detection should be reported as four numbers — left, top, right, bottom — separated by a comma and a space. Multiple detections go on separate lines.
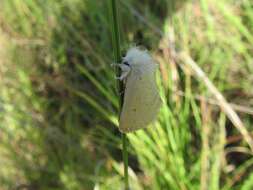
0, 0, 253, 190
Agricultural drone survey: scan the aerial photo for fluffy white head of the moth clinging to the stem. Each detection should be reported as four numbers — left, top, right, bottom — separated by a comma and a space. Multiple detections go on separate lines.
123, 47, 154, 66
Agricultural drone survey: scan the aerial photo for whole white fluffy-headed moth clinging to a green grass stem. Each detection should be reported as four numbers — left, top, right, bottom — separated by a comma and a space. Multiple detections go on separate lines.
115, 47, 162, 133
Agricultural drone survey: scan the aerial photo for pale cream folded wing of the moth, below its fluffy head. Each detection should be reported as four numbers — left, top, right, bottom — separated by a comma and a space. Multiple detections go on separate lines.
119, 64, 162, 132
